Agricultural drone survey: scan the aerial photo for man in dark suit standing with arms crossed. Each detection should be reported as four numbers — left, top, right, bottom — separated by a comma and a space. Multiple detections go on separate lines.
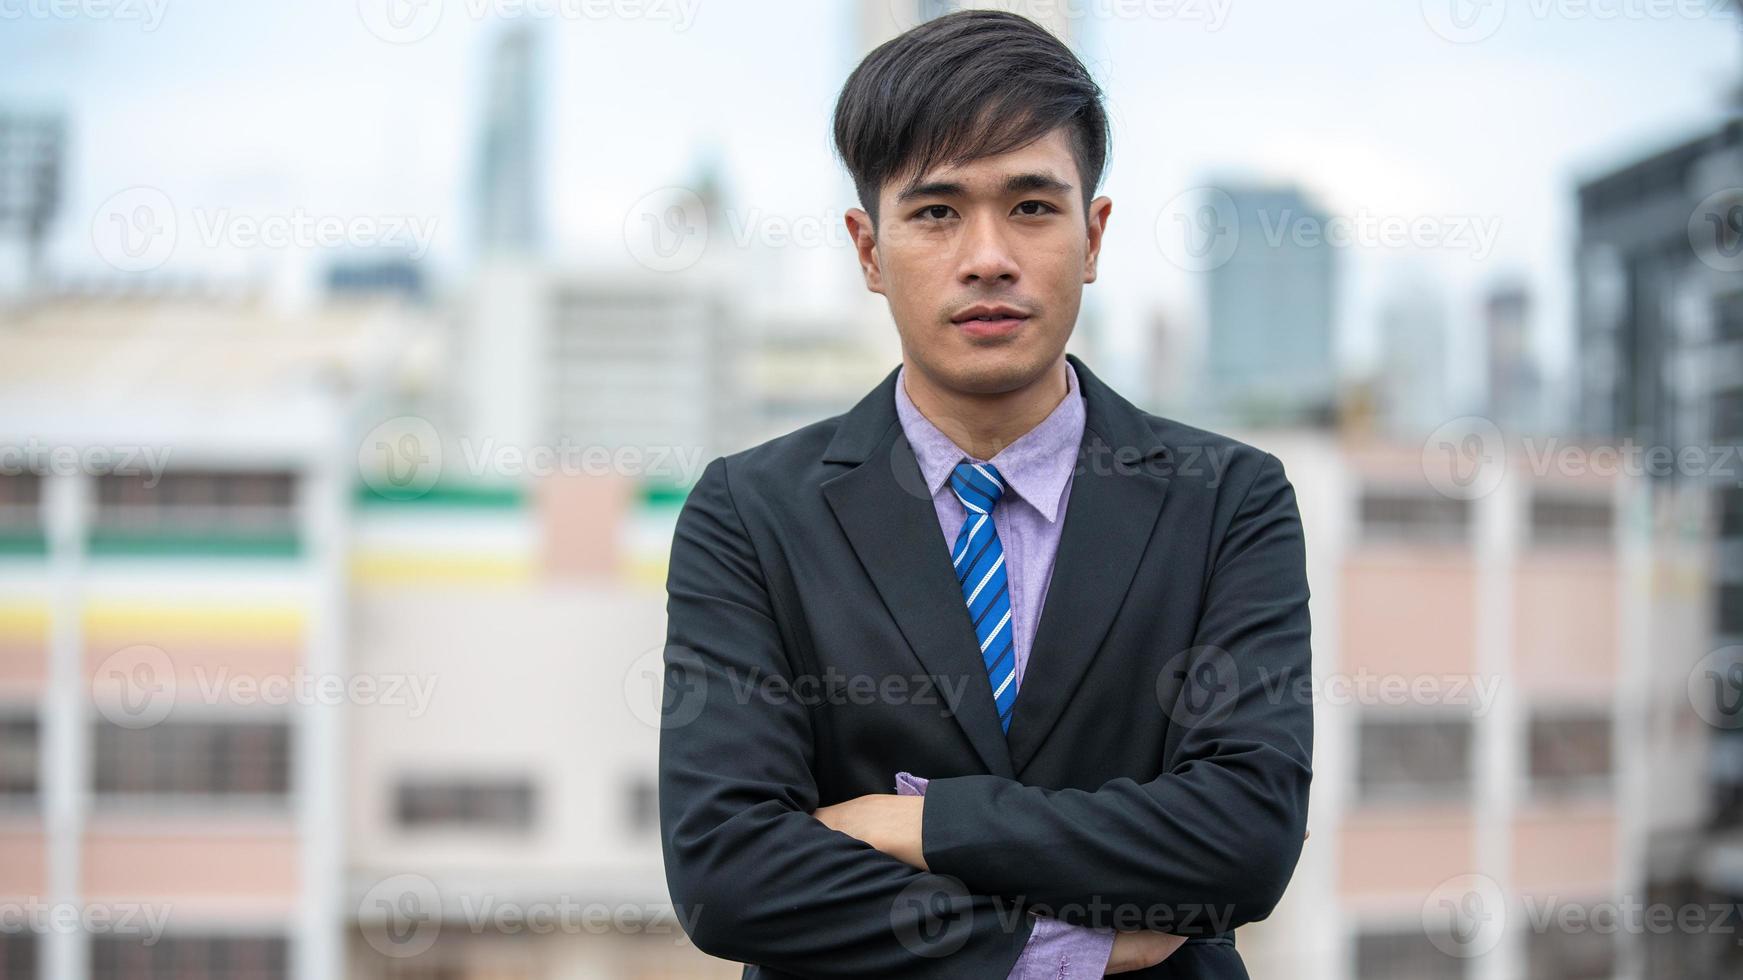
659, 10, 1312, 978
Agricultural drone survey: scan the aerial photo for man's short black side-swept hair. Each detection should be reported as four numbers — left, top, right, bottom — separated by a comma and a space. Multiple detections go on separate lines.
835, 10, 1110, 227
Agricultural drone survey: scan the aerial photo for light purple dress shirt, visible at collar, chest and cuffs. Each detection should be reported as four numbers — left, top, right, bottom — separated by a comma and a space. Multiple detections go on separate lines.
896, 363, 1114, 980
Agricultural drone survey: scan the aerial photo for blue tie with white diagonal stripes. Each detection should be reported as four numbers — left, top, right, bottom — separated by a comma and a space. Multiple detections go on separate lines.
950, 462, 1016, 734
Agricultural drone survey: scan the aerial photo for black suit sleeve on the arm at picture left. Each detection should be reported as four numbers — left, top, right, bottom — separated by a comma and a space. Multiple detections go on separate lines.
659, 459, 1034, 980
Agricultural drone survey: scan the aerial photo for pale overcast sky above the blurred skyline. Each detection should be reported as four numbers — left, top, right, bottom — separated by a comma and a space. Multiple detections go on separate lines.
0, 0, 1743, 406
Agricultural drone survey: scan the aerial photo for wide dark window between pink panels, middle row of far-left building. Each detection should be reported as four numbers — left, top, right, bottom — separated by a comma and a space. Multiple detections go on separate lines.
94, 722, 291, 799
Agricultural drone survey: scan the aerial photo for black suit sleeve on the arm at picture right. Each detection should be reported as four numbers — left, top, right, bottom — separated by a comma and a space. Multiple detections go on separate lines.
922, 453, 1312, 936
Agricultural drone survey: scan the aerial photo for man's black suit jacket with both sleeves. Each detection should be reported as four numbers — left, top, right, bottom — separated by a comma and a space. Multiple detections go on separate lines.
659, 356, 1312, 980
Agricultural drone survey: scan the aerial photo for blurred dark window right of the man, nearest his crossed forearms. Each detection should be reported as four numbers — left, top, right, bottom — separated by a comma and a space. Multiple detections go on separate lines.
1356, 707, 1471, 802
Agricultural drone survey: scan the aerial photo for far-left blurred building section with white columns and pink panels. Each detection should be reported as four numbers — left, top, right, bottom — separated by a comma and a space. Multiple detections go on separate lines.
0, 284, 414, 980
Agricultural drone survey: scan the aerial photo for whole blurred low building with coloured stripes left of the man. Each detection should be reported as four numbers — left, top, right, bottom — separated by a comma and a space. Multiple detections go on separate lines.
0, 279, 737, 980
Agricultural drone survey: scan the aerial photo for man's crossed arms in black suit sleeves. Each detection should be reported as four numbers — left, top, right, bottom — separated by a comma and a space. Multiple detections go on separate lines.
659, 455, 1312, 978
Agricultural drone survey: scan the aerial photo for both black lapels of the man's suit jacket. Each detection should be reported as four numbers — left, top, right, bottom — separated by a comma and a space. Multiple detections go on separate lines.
823, 354, 1168, 778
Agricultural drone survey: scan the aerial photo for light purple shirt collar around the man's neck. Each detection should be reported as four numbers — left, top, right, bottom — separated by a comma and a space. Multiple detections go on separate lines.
896, 361, 1086, 523
